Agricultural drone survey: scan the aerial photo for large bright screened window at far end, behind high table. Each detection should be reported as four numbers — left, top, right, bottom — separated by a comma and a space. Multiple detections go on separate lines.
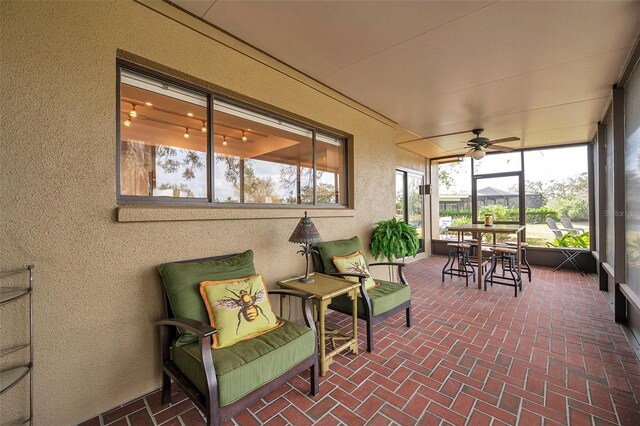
432, 145, 589, 249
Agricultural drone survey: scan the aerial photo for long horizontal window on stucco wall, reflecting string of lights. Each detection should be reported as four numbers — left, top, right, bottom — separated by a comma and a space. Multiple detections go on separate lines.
118, 63, 347, 206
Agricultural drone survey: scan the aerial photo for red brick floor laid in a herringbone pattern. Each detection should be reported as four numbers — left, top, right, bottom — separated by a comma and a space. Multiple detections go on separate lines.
81, 257, 640, 426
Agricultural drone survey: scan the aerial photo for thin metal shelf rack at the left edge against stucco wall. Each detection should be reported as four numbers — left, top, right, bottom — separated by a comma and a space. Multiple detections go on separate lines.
0, 265, 35, 424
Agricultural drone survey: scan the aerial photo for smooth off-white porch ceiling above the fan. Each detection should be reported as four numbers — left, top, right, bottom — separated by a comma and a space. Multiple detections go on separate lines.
174, 0, 640, 157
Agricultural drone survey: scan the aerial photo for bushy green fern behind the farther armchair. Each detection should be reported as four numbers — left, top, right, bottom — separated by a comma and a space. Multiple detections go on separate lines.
370, 218, 420, 262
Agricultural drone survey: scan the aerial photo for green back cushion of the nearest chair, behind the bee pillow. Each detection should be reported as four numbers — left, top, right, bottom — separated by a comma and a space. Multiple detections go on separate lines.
158, 250, 256, 346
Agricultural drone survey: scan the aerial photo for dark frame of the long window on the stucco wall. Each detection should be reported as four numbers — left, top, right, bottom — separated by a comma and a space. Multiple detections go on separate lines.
115, 58, 353, 209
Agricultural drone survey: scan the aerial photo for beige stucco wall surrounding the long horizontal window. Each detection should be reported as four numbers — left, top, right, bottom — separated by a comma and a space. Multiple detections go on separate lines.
0, 1, 430, 425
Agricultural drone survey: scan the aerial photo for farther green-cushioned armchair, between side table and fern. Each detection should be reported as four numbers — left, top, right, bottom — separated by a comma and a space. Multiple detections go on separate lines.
313, 237, 411, 352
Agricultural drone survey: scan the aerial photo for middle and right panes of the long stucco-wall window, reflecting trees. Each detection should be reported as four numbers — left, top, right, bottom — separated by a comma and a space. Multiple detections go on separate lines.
214, 101, 346, 204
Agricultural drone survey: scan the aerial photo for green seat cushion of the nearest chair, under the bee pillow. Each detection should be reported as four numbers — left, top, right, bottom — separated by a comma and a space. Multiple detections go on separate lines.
173, 320, 316, 407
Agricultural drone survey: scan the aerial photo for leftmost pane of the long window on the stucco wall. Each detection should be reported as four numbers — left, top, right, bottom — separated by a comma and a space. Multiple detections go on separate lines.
119, 69, 208, 201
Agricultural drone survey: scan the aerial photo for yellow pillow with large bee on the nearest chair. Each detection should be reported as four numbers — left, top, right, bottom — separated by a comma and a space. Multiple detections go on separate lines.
200, 274, 283, 349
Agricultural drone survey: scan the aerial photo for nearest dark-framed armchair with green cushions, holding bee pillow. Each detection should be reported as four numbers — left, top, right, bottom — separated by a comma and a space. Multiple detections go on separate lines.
158, 250, 318, 425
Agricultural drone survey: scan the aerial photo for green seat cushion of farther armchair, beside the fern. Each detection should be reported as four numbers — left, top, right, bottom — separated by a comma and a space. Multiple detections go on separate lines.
329, 280, 411, 315
